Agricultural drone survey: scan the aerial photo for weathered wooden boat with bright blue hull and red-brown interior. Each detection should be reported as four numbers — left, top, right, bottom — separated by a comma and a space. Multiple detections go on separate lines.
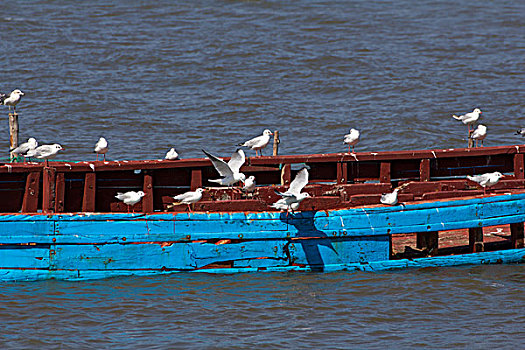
0, 146, 525, 281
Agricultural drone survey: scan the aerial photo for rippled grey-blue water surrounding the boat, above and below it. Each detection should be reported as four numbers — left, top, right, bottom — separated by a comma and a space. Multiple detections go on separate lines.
0, 0, 525, 349
